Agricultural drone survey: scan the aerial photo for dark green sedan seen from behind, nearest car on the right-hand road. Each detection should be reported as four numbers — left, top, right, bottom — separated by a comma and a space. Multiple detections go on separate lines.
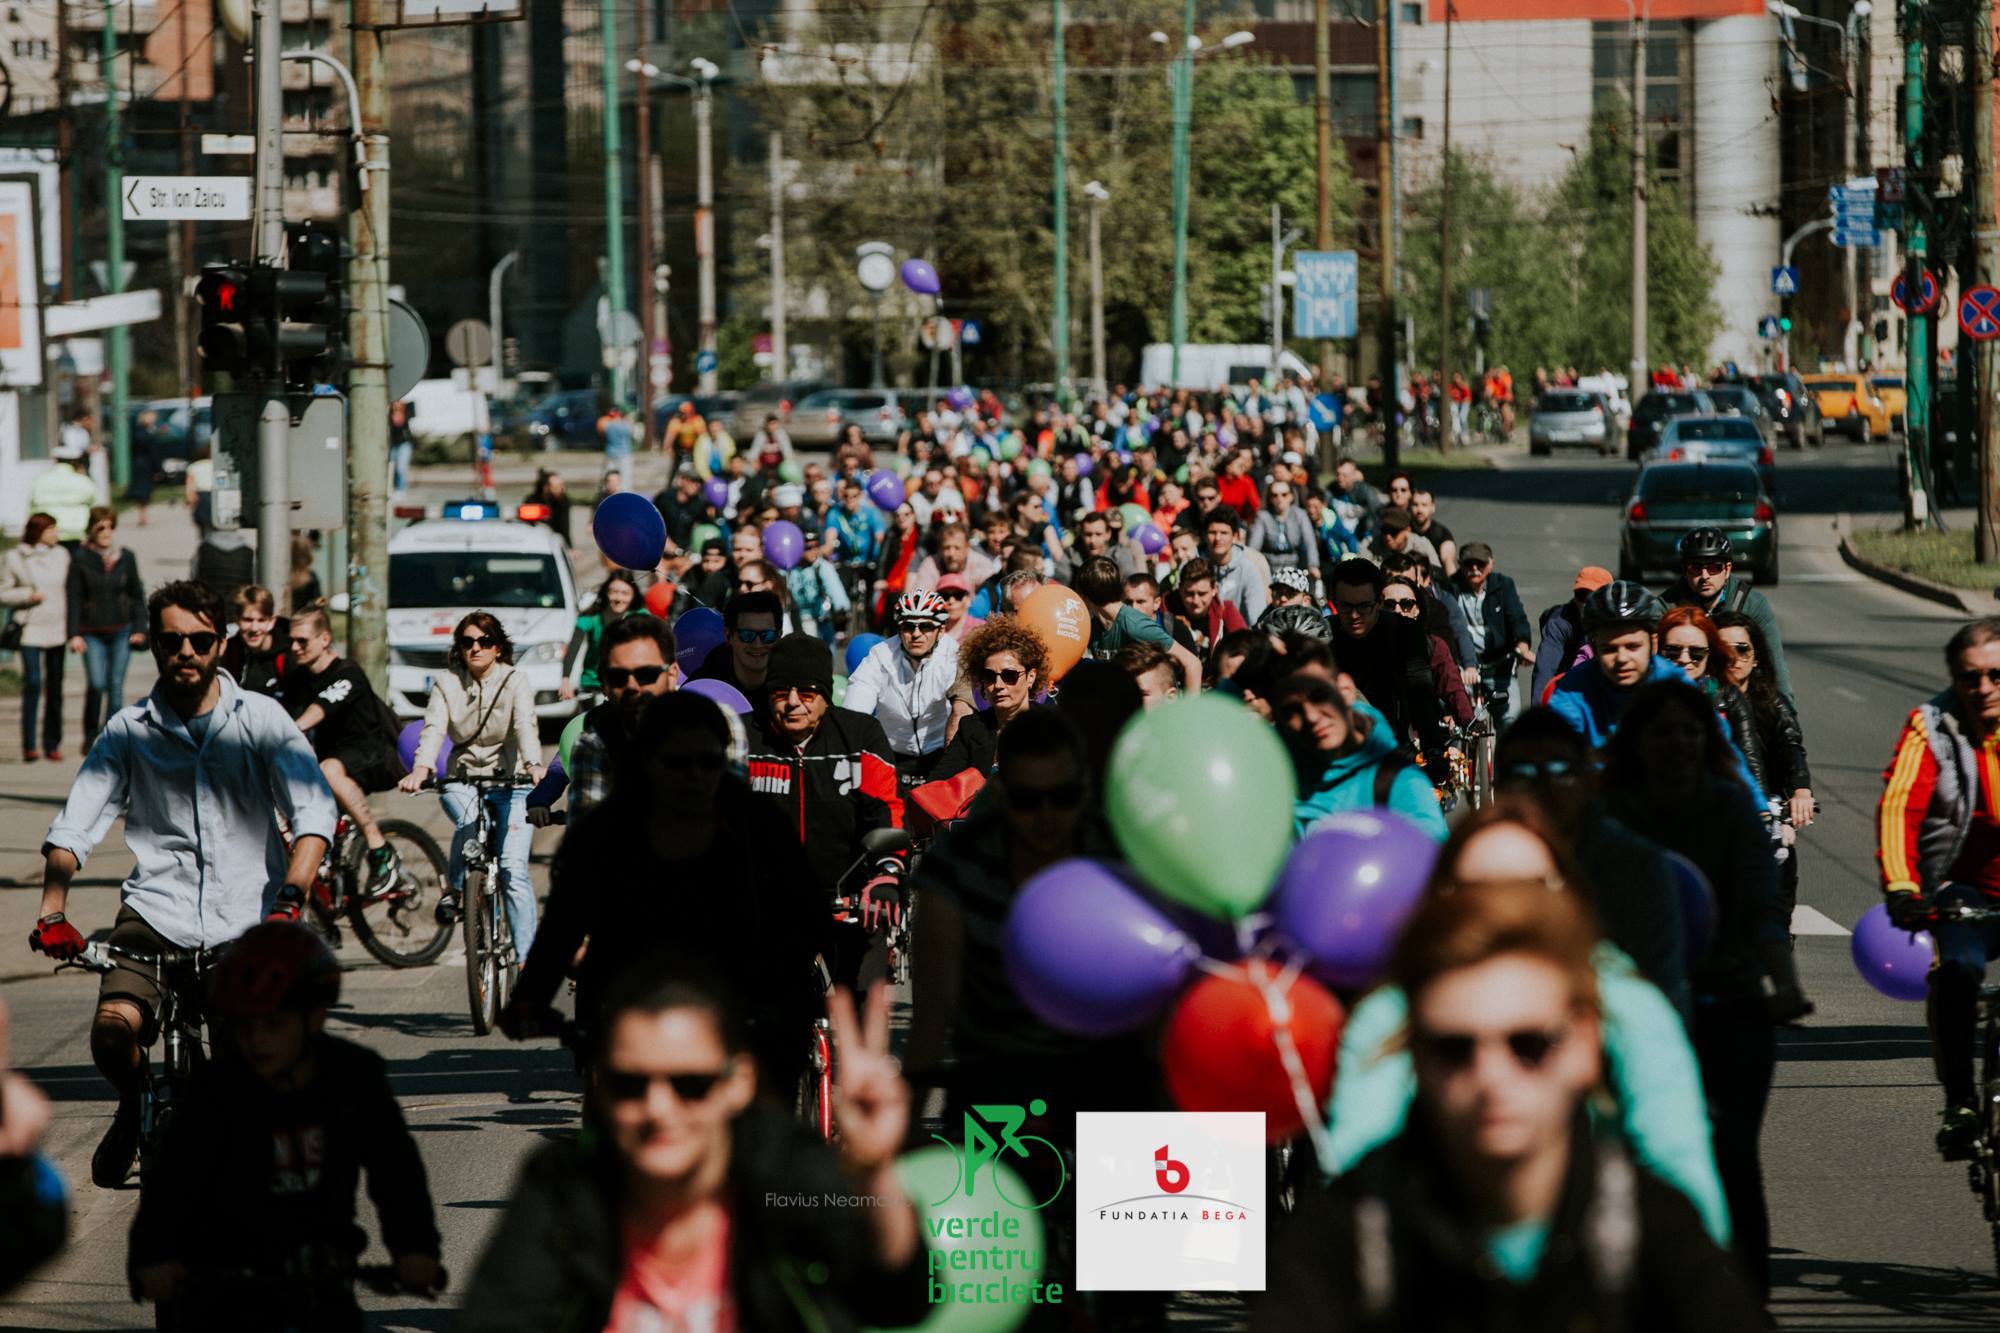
1618, 460, 1778, 582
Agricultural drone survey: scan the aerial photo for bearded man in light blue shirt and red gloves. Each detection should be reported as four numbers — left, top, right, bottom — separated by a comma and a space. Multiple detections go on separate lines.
28, 580, 334, 1189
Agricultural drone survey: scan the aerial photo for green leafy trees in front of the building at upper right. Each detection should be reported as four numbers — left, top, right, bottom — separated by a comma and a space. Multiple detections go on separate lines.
1402, 102, 1722, 380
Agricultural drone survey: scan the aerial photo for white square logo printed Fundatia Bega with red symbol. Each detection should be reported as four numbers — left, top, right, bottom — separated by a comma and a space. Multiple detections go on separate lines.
1074, 1111, 1268, 1291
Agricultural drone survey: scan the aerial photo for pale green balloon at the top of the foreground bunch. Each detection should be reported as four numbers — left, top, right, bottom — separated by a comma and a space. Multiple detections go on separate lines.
1104, 695, 1296, 919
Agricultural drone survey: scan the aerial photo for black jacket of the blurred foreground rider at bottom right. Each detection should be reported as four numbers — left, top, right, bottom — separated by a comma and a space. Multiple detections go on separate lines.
1250, 1115, 1764, 1333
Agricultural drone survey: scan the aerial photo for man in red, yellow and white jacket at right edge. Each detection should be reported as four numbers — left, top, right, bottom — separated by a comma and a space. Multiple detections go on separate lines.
1876, 616, 2000, 1161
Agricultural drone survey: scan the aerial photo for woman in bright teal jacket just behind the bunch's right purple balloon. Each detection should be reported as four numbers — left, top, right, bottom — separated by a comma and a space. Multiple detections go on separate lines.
1272, 675, 1444, 843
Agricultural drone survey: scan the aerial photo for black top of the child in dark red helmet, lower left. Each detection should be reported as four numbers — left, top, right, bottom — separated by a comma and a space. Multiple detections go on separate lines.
126, 1037, 438, 1275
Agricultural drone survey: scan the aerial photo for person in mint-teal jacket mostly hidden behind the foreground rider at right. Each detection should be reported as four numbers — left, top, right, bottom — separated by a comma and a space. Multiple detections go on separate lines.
1326, 800, 1730, 1247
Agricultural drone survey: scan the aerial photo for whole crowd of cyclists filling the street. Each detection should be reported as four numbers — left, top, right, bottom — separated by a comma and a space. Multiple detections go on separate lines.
0, 384, 2000, 1329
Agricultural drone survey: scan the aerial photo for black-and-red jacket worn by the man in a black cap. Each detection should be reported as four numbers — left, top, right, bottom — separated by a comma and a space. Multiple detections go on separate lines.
750, 705, 902, 897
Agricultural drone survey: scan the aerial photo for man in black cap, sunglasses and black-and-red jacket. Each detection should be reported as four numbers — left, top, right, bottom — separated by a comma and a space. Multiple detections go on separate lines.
750, 634, 902, 989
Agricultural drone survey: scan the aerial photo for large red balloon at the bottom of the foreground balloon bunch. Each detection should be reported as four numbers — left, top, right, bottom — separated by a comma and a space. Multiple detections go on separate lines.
1162, 961, 1346, 1143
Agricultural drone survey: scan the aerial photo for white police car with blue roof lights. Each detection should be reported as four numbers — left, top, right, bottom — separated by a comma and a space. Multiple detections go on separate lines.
388, 500, 578, 721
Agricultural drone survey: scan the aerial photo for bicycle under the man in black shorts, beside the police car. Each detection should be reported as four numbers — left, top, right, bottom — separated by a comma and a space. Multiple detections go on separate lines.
286, 815, 452, 967
